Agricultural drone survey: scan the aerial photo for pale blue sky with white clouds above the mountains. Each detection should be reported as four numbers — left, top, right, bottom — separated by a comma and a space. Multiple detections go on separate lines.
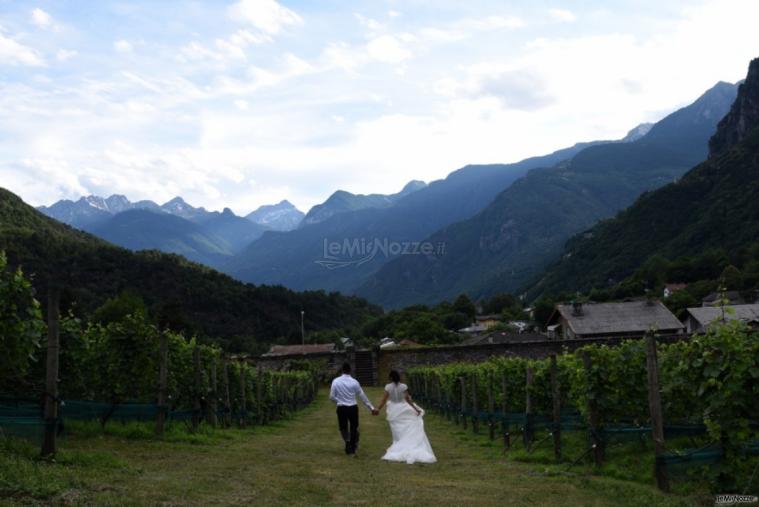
0, 0, 759, 214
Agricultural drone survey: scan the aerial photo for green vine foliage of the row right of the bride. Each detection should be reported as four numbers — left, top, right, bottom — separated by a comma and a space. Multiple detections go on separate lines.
409, 321, 759, 491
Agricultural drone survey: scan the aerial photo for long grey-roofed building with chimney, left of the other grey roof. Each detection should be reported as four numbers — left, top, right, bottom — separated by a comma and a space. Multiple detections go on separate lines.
548, 301, 685, 339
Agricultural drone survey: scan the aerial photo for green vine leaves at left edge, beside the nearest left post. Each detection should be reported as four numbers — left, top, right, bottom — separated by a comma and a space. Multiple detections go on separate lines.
0, 251, 45, 388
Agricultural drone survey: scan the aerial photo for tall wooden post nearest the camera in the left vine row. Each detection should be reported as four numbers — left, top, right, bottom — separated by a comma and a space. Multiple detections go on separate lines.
42, 283, 61, 457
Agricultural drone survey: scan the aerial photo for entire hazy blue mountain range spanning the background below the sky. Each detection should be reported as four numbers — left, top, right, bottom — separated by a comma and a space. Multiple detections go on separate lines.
32, 67, 756, 308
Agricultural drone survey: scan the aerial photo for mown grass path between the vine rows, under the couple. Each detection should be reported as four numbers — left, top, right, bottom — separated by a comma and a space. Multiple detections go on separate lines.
47, 388, 678, 507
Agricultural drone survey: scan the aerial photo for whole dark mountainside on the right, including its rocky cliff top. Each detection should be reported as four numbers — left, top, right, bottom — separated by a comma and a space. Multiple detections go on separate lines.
529, 58, 759, 296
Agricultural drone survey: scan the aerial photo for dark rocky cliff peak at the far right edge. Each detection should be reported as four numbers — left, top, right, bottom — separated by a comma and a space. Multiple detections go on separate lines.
709, 58, 759, 157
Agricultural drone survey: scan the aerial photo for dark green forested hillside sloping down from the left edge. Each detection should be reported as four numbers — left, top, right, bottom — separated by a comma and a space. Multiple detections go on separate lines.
0, 188, 379, 350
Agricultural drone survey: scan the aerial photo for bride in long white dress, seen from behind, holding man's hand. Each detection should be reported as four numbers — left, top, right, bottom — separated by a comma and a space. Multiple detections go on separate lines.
377, 370, 437, 464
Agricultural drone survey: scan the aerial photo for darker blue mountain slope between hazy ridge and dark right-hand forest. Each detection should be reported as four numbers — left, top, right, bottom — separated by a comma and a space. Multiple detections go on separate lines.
357, 83, 736, 307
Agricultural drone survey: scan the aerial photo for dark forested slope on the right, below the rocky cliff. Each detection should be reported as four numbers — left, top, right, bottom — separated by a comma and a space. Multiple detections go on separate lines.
530, 127, 759, 296
